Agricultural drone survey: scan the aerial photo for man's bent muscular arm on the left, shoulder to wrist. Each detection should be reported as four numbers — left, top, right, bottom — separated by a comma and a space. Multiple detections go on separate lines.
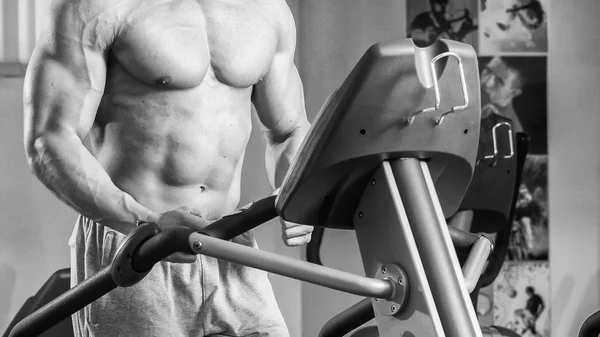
23, 0, 154, 233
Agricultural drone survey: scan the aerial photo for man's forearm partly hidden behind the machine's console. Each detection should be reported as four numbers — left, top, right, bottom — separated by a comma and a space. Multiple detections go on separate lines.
265, 122, 310, 189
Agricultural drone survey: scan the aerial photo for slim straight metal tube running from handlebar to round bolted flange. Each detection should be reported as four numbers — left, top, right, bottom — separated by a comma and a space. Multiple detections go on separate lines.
189, 233, 395, 299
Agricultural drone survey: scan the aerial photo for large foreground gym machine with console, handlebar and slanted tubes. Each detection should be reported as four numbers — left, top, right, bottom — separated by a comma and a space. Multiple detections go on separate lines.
9, 39, 516, 337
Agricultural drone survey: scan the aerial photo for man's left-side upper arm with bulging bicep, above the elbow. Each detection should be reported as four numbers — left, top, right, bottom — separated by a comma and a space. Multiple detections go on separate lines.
23, 1, 106, 146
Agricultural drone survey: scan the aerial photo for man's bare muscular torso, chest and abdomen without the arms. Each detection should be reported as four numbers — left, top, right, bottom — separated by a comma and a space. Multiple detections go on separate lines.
90, 0, 278, 219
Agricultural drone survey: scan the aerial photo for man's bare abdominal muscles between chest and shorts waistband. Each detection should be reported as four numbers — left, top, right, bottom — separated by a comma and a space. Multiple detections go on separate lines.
90, 85, 251, 218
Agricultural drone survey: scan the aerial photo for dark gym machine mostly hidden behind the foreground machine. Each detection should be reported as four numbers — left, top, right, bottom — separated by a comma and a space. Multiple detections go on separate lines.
306, 107, 528, 337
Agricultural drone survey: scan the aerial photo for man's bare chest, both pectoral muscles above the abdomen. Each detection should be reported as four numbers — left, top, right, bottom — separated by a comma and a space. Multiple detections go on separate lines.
112, 0, 278, 89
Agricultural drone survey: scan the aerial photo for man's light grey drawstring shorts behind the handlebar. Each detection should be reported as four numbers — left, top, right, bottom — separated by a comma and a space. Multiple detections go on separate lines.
69, 216, 289, 337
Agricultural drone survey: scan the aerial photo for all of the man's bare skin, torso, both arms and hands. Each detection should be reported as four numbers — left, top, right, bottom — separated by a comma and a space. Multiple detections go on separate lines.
24, 0, 312, 262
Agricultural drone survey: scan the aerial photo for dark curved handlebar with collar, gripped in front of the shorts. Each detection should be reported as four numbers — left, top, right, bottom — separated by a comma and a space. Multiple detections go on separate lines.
9, 195, 277, 337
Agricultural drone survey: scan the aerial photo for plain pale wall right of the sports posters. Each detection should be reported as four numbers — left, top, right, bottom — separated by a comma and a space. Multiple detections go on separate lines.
548, 0, 600, 337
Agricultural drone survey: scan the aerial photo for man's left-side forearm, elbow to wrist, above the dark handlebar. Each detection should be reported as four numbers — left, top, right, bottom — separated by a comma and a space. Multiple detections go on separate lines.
27, 130, 155, 233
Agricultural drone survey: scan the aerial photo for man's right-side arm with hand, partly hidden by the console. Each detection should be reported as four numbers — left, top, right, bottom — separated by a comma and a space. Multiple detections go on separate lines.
252, 0, 312, 246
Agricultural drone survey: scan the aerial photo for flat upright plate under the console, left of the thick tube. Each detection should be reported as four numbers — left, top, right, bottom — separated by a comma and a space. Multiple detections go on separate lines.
353, 161, 446, 337
